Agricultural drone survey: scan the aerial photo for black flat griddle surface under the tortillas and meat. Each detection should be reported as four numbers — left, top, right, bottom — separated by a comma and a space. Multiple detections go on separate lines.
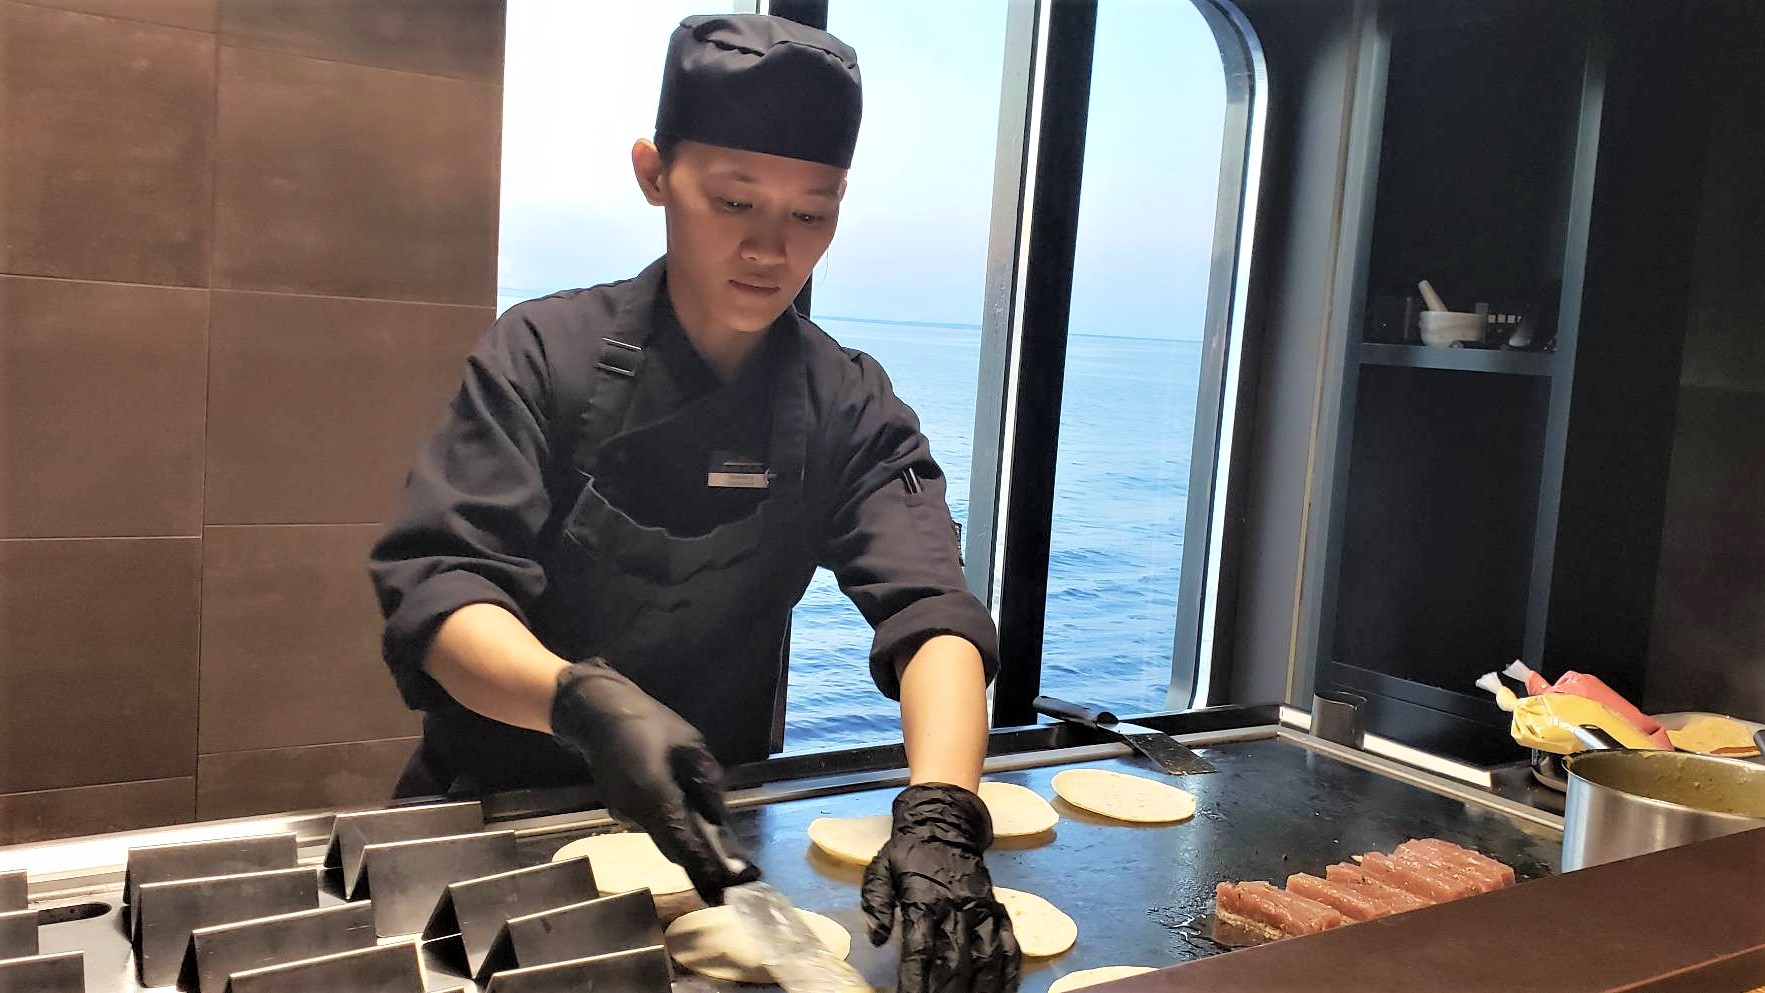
522, 737, 1562, 993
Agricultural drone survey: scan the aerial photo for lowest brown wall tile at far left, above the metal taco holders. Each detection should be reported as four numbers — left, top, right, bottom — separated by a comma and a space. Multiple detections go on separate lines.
0, 776, 196, 845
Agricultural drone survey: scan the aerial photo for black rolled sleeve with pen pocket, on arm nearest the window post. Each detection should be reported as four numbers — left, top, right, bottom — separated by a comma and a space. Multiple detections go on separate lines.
821, 355, 999, 700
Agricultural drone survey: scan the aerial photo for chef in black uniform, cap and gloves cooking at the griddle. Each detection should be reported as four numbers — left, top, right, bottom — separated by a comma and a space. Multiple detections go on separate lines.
371, 14, 1020, 993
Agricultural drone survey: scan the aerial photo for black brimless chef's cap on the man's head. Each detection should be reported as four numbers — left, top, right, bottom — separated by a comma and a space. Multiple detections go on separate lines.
657, 14, 863, 169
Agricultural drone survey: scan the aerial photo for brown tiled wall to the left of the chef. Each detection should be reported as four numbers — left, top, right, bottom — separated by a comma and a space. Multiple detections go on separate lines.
0, 0, 505, 845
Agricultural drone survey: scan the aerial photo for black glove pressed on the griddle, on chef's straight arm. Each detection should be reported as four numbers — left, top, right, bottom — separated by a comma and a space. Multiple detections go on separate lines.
863, 783, 1024, 993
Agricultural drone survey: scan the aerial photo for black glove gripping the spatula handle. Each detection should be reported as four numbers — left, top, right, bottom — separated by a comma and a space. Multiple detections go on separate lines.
551, 658, 759, 905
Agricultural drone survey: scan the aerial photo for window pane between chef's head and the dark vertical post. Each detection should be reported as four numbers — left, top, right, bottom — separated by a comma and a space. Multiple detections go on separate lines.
785, 0, 1006, 751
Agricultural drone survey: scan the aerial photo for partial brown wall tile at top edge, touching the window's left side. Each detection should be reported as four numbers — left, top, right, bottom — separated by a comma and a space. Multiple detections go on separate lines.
221, 0, 507, 83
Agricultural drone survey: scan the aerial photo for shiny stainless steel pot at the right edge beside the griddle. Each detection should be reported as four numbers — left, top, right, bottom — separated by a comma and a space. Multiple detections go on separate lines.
1562, 728, 1765, 871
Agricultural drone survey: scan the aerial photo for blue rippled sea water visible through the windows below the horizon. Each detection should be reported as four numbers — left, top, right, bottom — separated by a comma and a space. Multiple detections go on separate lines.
785, 317, 1200, 751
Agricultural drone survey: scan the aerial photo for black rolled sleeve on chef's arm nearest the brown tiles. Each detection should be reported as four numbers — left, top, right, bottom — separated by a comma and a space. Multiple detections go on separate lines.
369, 307, 551, 709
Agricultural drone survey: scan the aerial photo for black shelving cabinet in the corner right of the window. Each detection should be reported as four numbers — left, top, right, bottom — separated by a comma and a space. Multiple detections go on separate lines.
1304, 0, 1694, 762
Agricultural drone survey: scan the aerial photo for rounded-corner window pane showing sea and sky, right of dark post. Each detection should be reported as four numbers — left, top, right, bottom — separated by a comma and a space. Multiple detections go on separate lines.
1041, 0, 1227, 713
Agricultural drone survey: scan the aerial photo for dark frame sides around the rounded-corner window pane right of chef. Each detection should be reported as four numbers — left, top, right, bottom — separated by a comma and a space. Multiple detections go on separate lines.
967, 0, 1267, 727
